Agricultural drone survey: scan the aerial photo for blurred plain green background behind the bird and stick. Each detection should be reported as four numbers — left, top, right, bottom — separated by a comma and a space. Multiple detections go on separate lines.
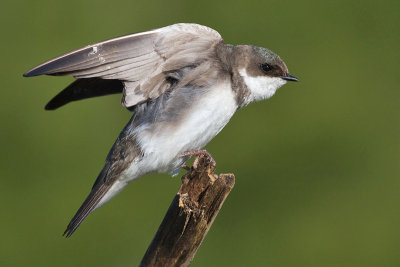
0, 0, 400, 266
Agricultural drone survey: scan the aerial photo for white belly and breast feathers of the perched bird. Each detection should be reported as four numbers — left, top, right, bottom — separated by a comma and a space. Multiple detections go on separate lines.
133, 84, 237, 172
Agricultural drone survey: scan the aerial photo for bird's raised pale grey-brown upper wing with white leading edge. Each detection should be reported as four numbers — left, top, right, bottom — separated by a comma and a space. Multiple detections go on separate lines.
24, 23, 222, 107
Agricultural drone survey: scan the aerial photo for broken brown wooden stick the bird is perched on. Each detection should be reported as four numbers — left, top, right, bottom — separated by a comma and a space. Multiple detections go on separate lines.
140, 156, 235, 267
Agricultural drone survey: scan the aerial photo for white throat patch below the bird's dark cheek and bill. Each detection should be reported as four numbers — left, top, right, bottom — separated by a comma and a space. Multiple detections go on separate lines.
239, 68, 286, 105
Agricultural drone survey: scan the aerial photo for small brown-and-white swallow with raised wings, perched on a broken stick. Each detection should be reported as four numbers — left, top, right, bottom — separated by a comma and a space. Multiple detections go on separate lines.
23, 23, 298, 237
